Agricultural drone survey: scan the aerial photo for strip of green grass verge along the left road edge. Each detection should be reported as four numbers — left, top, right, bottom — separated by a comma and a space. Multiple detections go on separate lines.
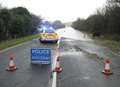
0, 34, 40, 50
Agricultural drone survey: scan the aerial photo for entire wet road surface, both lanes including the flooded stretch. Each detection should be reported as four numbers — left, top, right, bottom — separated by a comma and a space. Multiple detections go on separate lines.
0, 28, 120, 87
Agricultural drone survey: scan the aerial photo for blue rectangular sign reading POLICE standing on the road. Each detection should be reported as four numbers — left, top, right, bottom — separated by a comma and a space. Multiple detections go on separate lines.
31, 48, 51, 64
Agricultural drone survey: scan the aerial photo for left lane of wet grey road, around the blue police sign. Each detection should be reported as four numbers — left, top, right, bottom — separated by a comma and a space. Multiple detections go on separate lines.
0, 39, 56, 87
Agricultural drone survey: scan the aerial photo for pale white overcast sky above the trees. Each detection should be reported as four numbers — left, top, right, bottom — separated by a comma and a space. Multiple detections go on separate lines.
0, 0, 106, 22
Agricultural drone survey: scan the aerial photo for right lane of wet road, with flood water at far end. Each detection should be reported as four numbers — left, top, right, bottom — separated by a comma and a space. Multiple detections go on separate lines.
57, 29, 120, 87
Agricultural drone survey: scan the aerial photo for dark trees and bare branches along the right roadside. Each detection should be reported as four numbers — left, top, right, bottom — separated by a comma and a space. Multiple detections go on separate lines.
72, 0, 120, 40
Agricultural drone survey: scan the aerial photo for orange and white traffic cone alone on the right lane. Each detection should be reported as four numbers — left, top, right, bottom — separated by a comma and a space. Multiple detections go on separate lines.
102, 59, 113, 75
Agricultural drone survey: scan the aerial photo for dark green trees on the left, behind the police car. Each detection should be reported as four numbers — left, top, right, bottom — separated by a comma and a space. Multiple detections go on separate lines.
0, 7, 41, 41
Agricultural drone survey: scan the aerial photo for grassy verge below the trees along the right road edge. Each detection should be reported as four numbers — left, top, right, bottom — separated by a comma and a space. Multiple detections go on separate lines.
87, 33, 120, 54
